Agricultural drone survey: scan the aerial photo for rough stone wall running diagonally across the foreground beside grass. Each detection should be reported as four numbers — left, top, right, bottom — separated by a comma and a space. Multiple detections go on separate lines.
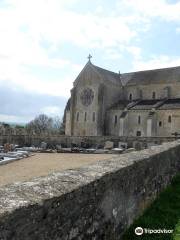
0, 141, 180, 240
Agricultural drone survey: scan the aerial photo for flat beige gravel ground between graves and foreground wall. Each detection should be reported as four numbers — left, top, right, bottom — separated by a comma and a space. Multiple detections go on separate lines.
0, 153, 114, 186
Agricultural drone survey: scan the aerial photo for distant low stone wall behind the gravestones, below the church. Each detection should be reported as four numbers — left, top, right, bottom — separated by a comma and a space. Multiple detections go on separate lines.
0, 135, 176, 149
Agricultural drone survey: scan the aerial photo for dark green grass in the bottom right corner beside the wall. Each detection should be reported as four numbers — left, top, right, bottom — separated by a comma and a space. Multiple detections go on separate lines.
122, 174, 180, 240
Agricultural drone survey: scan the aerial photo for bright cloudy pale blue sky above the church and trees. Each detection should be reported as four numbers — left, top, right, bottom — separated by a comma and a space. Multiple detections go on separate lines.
0, 0, 180, 123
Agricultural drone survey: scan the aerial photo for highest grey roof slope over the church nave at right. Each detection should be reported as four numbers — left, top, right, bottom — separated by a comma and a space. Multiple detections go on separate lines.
121, 67, 180, 86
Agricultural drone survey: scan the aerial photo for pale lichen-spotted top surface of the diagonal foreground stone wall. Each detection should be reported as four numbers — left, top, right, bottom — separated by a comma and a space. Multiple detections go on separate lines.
0, 140, 180, 219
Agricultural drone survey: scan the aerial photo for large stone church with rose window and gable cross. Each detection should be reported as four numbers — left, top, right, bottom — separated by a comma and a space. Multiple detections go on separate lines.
65, 56, 180, 137
